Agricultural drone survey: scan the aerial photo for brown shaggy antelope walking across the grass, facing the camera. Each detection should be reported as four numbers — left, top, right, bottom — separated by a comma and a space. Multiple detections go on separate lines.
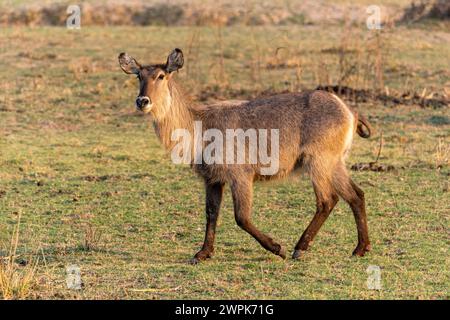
118, 48, 371, 264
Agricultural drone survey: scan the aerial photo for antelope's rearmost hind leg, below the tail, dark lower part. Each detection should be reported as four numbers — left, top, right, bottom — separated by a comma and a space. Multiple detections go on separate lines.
333, 163, 371, 257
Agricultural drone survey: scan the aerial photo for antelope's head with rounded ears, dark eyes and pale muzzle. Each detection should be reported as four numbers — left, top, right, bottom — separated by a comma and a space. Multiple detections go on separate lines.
119, 48, 184, 117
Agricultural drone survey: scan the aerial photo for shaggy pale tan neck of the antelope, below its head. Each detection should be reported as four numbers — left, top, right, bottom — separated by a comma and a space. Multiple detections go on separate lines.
153, 79, 194, 151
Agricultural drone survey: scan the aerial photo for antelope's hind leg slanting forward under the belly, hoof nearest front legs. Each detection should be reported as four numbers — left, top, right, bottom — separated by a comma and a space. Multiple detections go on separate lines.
292, 182, 339, 259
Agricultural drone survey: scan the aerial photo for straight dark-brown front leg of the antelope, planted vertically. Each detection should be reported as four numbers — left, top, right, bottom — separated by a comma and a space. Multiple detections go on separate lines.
191, 183, 224, 264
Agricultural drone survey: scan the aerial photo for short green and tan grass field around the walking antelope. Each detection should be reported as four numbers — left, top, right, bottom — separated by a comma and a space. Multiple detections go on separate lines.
0, 25, 450, 299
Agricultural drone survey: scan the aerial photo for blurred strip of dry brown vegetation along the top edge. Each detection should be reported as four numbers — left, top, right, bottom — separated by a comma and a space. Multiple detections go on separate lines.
0, 0, 409, 26
